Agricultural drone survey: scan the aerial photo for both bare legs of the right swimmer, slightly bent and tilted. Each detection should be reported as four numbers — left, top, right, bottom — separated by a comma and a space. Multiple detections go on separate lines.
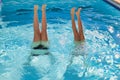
71, 8, 85, 41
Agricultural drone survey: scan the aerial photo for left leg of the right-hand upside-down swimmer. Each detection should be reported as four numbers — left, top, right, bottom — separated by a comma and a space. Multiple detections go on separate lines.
71, 8, 79, 41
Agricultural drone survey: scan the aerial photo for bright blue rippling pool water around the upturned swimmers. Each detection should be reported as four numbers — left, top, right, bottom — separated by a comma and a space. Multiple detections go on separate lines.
0, 0, 120, 80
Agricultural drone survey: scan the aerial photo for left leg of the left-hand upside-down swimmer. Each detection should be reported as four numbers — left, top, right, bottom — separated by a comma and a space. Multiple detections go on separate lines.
33, 5, 41, 42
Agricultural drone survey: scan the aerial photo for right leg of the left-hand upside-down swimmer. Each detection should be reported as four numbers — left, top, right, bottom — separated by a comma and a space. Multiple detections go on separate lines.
41, 5, 48, 41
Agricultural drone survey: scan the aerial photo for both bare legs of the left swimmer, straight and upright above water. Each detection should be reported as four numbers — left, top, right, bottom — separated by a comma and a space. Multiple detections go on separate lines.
33, 5, 48, 42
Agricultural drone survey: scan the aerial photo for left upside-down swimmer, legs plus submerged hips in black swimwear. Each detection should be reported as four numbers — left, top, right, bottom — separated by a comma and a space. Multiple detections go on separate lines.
32, 4, 49, 56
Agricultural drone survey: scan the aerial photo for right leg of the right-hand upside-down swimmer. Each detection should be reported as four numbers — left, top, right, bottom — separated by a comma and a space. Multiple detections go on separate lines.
76, 8, 85, 41
